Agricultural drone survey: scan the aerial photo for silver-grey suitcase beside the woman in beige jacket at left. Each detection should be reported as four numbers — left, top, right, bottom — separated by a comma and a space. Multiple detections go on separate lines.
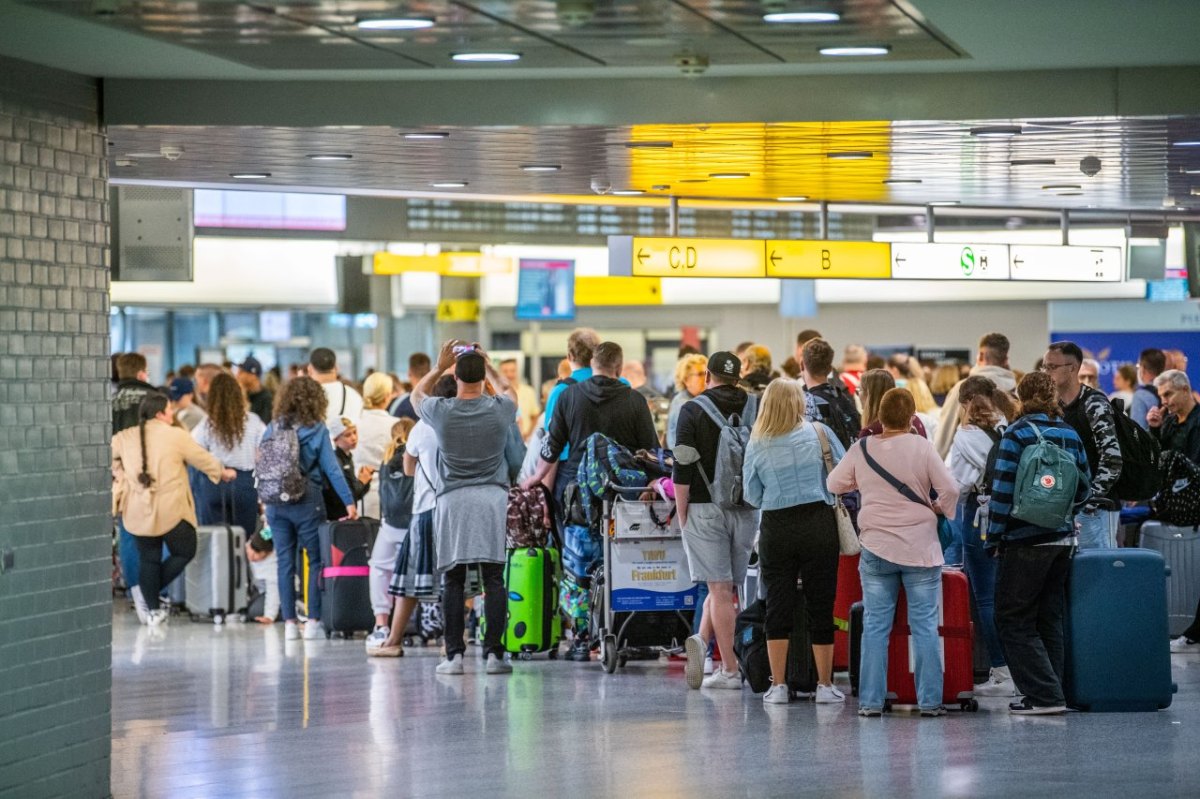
184, 524, 248, 624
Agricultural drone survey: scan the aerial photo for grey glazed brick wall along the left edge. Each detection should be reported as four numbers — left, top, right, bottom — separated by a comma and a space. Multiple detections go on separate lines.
0, 59, 112, 799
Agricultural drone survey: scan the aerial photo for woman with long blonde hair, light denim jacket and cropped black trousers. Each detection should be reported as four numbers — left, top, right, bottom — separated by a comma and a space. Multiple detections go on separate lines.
743, 380, 846, 704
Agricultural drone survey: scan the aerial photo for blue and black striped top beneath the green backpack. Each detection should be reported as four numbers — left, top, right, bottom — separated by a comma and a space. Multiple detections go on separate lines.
988, 414, 1092, 547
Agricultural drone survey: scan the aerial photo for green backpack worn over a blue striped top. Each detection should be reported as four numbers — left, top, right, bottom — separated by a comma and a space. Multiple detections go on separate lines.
1012, 422, 1079, 530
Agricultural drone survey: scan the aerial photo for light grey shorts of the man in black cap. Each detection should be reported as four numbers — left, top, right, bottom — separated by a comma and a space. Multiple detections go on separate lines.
683, 503, 758, 585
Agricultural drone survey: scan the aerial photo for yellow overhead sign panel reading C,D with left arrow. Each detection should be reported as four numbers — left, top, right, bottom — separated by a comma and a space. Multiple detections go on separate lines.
631, 236, 766, 277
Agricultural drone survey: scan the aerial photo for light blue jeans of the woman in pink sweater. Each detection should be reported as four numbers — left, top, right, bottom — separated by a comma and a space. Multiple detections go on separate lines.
858, 547, 942, 710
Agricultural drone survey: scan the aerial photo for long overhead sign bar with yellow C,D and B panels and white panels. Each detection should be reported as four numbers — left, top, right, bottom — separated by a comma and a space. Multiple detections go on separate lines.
608, 236, 1124, 283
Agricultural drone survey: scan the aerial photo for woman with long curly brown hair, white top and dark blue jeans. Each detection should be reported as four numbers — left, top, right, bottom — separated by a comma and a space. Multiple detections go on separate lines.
192, 372, 266, 539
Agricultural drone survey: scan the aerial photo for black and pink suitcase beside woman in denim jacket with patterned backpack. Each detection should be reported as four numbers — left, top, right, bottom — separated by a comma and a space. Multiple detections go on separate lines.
318, 518, 379, 638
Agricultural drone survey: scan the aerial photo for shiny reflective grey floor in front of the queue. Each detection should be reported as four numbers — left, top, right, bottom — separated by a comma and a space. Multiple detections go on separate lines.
112, 603, 1200, 799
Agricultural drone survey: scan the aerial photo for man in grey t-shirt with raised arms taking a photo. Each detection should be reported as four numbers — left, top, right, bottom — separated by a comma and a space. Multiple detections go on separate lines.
413, 341, 517, 674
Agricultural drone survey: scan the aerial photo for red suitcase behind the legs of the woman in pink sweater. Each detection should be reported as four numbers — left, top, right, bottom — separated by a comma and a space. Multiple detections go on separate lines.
888, 569, 979, 713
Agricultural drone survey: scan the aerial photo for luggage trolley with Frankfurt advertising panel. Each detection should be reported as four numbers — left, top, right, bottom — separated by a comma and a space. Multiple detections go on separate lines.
592, 489, 697, 674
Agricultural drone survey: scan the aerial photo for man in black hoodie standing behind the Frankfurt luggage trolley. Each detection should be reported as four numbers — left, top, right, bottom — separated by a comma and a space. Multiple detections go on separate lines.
524, 341, 659, 501
